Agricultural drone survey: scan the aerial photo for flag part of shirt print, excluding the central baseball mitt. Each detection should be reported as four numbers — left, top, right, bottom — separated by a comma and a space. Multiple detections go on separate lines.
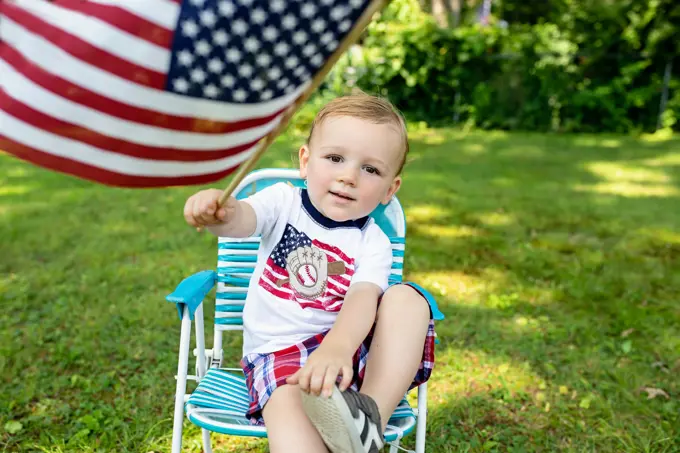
259, 224, 354, 312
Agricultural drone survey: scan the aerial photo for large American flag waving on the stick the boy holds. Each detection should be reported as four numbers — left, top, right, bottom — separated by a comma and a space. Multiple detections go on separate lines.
0, 0, 370, 187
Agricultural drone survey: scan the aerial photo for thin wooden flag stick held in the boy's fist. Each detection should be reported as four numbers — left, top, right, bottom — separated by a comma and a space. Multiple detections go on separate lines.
219, 0, 389, 206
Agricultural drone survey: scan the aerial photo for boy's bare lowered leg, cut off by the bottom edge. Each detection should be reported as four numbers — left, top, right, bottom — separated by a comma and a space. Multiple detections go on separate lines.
262, 385, 328, 453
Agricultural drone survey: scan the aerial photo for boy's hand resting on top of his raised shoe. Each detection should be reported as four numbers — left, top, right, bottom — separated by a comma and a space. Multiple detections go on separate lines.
286, 343, 354, 398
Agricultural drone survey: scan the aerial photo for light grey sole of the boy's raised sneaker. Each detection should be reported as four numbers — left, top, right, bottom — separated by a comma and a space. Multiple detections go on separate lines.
301, 387, 364, 453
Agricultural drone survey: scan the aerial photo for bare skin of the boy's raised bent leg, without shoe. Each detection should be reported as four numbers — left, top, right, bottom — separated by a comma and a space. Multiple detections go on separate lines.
359, 285, 430, 432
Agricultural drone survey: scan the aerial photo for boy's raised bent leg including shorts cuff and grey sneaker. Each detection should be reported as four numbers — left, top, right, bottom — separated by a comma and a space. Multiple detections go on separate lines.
302, 285, 433, 453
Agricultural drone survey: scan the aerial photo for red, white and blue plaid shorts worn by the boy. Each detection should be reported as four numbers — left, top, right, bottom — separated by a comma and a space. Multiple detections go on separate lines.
241, 283, 435, 425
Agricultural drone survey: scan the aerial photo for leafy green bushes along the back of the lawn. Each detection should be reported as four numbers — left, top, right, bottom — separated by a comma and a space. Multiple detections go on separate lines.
326, 0, 680, 132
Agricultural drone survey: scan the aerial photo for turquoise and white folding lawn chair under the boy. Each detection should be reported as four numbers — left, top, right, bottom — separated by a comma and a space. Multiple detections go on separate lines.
166, 169, 443, 453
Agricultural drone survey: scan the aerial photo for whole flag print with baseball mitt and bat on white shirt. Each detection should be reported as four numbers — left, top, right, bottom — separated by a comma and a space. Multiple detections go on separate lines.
259, 224, 354, 312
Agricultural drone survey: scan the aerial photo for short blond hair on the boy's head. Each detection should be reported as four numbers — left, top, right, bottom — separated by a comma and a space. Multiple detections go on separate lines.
307, 93, 409, 175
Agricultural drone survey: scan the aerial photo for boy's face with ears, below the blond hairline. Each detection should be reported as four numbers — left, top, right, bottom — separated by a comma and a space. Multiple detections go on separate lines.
300, 116, 403, 222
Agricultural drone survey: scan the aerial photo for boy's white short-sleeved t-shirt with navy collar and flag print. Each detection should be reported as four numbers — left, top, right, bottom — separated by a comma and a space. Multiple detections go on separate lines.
243, 183, 392, 355
